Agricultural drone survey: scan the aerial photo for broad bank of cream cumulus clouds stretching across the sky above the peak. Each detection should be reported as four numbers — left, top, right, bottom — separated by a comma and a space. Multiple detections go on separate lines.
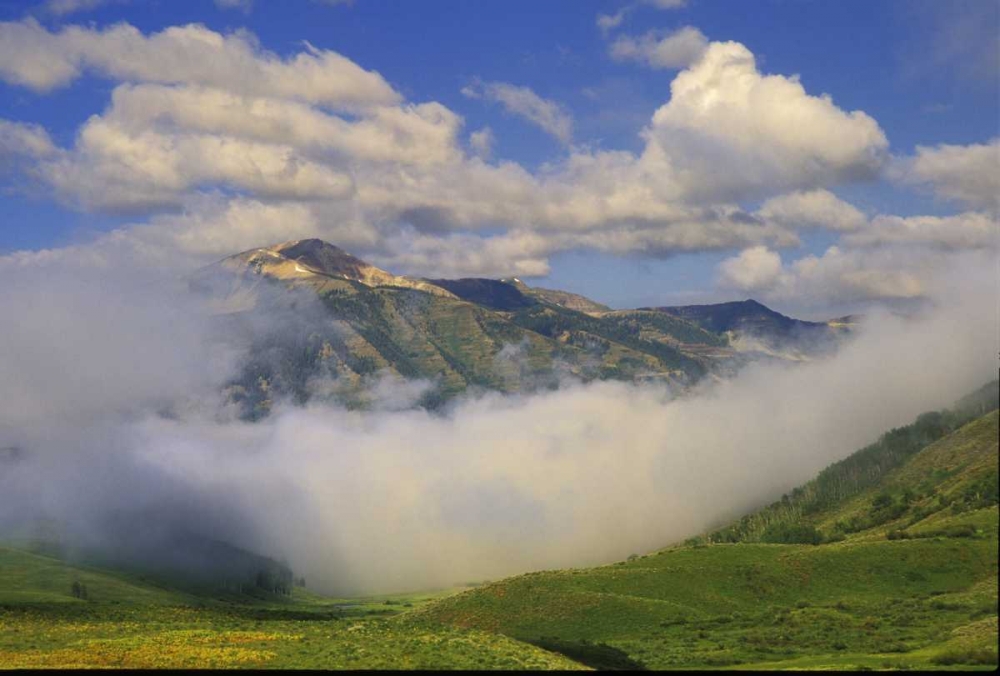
0, 19, 985, 298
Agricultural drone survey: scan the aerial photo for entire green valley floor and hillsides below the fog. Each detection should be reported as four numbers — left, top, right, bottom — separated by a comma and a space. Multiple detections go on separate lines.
0, 381, 1000, 670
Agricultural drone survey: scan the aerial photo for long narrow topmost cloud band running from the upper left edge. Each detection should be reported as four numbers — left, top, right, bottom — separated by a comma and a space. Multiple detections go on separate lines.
0, 18, 400, 108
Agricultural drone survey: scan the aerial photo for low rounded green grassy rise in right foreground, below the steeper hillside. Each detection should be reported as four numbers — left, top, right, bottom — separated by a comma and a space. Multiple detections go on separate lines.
421, 522, 997, 668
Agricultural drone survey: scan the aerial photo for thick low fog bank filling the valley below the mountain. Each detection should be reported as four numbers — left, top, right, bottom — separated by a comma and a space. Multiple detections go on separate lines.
0, 246, 1000, 593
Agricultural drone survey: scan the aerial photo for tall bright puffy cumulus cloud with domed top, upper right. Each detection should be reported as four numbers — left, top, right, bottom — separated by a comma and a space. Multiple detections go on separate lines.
645, 42, 888, 199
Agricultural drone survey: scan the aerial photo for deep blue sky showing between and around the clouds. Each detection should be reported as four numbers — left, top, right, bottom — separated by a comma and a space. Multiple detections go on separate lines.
0, 0, 1000, 311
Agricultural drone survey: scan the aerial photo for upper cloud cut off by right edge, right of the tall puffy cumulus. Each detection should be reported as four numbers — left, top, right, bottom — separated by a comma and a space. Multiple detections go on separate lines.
892, 138, 1000, 211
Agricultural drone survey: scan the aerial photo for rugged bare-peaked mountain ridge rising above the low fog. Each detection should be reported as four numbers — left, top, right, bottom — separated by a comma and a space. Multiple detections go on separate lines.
191, 239, 844, 418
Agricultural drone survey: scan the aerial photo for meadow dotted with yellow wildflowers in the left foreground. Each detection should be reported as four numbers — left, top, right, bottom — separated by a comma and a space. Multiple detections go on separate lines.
0, 547, 581, 669
